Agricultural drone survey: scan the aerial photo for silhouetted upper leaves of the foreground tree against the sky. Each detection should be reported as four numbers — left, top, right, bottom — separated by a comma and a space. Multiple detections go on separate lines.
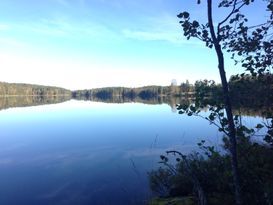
178, 0, 273, 76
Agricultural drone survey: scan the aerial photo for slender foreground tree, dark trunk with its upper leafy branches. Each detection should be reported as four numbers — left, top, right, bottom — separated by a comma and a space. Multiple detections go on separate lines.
178, 0, 273, 205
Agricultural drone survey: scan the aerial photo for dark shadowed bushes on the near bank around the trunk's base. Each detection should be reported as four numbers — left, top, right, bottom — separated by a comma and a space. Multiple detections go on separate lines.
149, 131, 273, 205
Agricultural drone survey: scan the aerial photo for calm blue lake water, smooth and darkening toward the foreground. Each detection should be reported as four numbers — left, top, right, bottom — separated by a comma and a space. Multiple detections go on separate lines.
0, 100, 260, 205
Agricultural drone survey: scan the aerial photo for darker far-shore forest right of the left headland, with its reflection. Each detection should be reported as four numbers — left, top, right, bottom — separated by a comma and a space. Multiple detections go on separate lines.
72, 74, 273, 105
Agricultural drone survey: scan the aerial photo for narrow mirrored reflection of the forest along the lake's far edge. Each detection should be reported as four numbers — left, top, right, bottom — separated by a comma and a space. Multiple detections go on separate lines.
0, 95, 273, 117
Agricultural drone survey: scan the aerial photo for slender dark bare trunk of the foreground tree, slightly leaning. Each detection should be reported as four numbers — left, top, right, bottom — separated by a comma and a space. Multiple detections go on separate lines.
207, 0, 241, 205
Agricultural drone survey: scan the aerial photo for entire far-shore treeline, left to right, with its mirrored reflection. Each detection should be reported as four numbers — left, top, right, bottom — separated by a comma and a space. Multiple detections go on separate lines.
0, 74, 273, 113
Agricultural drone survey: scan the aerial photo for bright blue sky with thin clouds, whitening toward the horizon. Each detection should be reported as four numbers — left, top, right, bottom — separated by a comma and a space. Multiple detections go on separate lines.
0, 0, 268, 90
